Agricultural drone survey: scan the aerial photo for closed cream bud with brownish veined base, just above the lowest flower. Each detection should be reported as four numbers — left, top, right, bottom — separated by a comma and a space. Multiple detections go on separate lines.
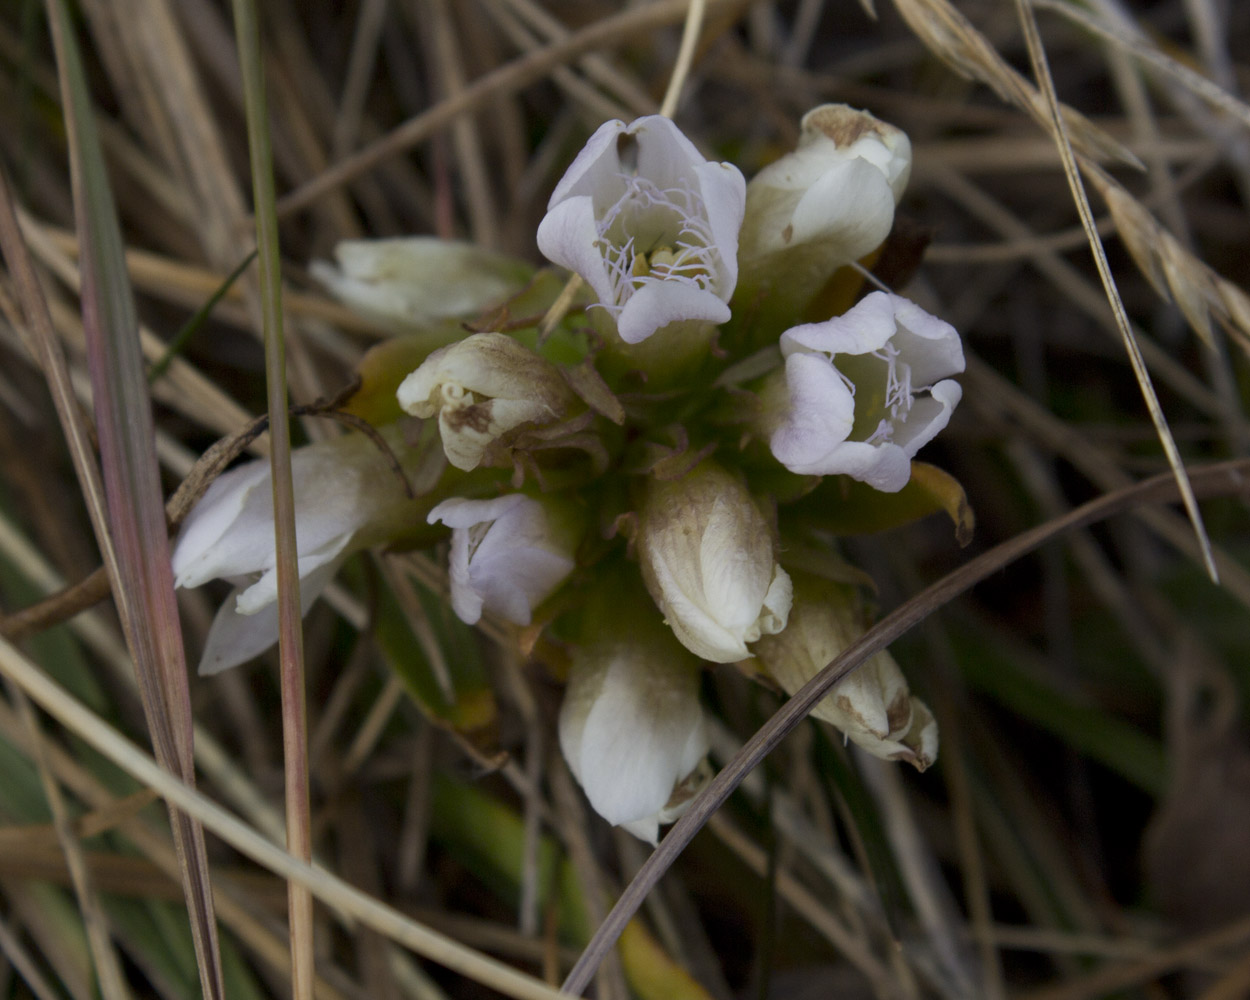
638, 461, 790, 663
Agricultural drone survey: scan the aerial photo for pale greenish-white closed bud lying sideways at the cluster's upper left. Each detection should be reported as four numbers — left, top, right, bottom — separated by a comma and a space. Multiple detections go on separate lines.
309, 236, 528, 326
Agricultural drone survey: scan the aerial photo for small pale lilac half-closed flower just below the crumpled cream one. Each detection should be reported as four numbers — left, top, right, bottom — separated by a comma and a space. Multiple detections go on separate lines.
429, 493, 581, 625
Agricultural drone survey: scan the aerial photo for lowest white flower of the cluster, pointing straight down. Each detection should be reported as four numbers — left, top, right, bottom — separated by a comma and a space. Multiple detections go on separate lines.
559, 619, 708, 844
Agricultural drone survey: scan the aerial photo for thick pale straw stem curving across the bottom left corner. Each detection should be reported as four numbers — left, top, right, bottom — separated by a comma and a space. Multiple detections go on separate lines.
0, 640, 572, 1000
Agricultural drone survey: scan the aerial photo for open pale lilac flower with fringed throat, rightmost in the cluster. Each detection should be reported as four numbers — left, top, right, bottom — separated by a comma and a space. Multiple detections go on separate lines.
770, 291, 964, 493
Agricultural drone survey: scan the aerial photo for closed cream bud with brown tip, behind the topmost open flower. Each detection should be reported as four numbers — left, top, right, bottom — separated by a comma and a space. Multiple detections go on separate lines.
740, 104, 911, 321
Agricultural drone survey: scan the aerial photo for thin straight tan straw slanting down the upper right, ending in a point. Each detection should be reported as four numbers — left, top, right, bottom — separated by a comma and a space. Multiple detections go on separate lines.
1016, 0, 1220, 581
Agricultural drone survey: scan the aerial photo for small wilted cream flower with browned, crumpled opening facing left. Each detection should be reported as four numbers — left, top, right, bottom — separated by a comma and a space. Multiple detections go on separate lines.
396, 333, 573, 471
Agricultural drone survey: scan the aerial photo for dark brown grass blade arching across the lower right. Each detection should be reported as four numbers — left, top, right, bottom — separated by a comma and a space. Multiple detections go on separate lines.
563, 460, 1250, 994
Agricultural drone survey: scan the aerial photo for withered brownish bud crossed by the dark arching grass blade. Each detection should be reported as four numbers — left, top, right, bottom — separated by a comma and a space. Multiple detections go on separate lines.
755, 575, 938, 771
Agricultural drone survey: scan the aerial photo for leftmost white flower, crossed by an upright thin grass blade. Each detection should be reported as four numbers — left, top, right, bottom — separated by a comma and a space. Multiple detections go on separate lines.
171, 429, 422, 674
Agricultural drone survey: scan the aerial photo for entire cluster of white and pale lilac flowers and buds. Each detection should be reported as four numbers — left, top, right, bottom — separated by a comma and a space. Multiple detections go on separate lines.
174, 105, 964, 843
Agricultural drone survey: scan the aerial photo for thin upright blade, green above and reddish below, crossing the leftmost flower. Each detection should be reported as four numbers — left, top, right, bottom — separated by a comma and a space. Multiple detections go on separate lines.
234, 0, 315, 1000
